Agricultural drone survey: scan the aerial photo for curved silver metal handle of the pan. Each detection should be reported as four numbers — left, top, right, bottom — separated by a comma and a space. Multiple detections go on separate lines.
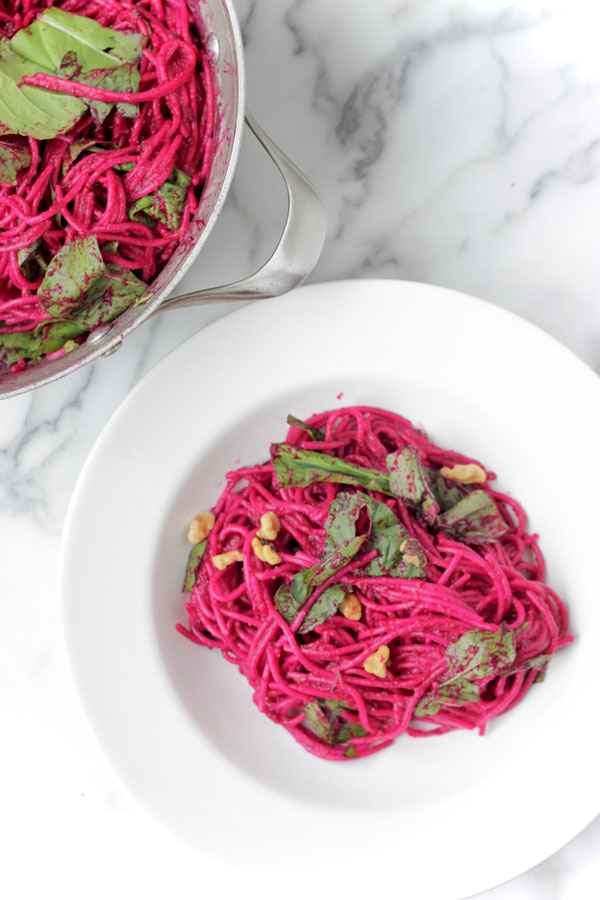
156, 111, 327, 312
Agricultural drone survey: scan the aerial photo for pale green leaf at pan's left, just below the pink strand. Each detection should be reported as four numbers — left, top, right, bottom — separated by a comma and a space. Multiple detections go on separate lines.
0, 42, 85, 140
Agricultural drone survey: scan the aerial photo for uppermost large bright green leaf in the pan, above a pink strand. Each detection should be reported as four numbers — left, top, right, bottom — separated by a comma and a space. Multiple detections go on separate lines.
10, 7, 143, 72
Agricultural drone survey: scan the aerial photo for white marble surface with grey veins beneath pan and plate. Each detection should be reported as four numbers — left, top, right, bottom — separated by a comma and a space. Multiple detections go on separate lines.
0, 0, 600, 900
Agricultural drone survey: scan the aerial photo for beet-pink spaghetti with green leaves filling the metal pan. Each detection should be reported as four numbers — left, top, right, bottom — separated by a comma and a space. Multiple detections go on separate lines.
0, 0, 215, 371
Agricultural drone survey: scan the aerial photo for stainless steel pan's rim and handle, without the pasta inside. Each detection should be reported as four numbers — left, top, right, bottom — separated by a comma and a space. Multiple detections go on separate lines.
0, 0, 327, 398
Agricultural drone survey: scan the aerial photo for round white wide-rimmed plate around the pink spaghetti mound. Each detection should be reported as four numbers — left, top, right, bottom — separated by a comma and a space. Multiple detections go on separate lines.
62, 281, 600, 900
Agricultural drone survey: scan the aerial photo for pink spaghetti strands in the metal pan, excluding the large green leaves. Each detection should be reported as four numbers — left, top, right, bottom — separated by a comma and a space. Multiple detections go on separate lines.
0, 0, 215, 370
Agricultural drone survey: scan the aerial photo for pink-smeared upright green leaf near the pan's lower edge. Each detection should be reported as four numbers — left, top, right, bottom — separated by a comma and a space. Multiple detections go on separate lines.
37, 235, 106, 317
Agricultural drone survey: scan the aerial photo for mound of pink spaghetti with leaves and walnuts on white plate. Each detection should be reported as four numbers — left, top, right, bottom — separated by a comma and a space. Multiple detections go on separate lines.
178, 407, 571, 760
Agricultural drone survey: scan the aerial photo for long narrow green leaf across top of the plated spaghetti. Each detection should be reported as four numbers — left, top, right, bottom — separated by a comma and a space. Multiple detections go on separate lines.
271, 444, 391, 494
